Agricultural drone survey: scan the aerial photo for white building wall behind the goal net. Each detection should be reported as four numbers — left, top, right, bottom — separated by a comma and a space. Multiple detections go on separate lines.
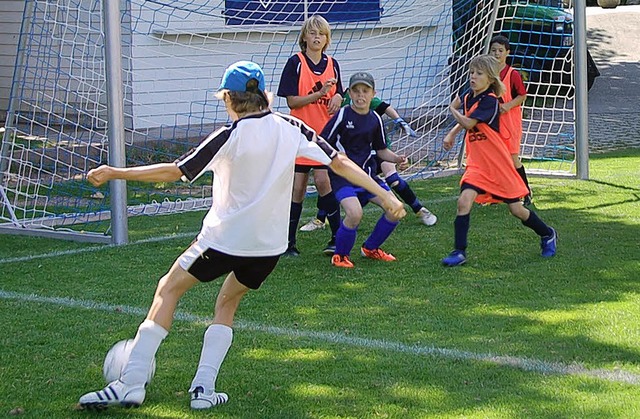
130, 0, 451, 129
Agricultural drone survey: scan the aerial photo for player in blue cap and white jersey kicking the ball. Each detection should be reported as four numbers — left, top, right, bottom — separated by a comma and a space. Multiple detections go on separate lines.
79, 61, 405, 409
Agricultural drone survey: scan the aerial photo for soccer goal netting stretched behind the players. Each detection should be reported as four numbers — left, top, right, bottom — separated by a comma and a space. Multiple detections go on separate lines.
0, 0, 592, 242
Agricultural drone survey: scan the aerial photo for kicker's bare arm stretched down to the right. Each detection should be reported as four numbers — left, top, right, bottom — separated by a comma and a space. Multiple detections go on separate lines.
329, 153, 407, 219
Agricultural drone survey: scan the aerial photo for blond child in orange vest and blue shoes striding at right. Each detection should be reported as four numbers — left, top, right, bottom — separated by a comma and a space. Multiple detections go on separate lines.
442, 55, 557, 266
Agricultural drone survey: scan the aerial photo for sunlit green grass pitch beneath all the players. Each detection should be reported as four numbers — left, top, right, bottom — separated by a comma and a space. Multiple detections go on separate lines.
0, 150, 640, 418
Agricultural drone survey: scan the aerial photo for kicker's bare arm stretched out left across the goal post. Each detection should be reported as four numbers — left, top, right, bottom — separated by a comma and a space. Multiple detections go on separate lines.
87, 163, 182, 186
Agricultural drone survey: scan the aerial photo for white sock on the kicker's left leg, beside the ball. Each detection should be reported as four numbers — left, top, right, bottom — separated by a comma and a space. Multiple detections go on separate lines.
120, 320, 169, 386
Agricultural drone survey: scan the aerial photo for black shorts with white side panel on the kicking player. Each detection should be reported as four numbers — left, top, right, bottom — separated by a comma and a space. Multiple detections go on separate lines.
178, 242, 280, 290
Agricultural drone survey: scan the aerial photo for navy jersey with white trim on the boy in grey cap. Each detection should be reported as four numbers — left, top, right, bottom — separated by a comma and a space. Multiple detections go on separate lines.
320, 106, 387, 190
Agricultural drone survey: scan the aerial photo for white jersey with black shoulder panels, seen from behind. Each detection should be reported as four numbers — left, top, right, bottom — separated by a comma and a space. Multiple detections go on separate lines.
176, 112, 337, 256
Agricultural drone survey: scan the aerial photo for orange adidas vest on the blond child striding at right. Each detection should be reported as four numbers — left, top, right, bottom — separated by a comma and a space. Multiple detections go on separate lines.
460, 93, 529, 203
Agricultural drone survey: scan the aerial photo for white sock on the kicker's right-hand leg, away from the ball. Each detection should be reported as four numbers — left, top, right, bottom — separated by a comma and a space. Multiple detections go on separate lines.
189, 324, 233, 392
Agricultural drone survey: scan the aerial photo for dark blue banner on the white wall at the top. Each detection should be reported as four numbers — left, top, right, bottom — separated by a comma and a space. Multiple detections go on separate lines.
224, 0, 382, 25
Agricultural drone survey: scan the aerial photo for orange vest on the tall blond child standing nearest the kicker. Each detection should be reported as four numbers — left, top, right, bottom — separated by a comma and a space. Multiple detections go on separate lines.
291, 52, 338, 166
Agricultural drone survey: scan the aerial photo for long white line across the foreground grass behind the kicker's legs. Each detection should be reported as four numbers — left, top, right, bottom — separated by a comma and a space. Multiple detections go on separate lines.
0, 290, 640, 385
